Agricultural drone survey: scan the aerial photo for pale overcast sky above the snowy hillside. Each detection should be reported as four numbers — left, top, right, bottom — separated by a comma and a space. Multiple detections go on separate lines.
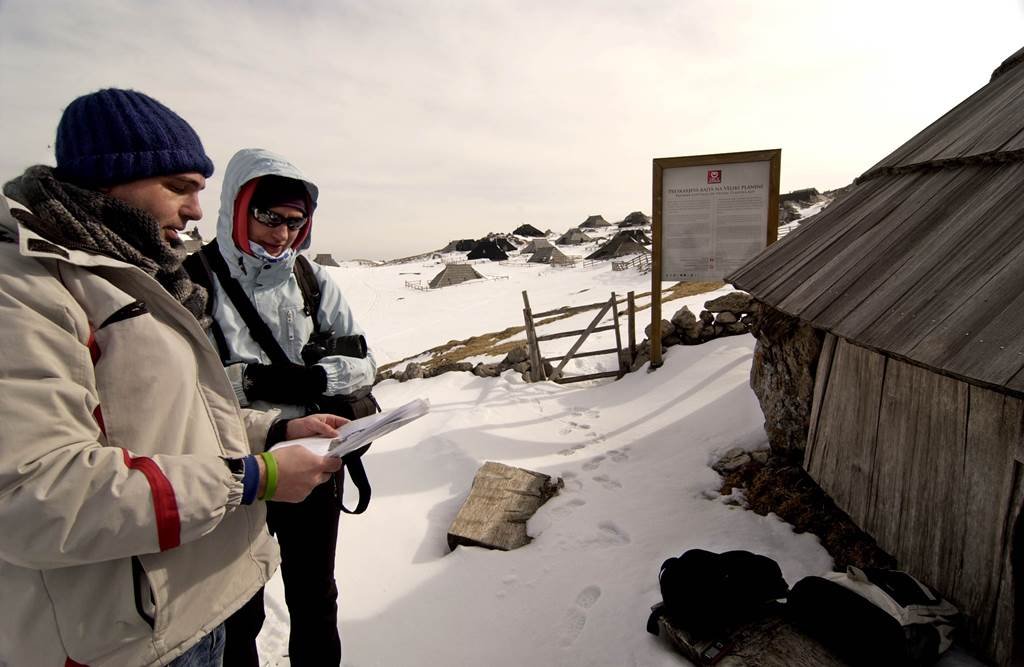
0, 0, 1024, 258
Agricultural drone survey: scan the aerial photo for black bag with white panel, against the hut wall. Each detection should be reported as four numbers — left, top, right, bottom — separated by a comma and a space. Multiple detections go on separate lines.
786, 567, 958, 666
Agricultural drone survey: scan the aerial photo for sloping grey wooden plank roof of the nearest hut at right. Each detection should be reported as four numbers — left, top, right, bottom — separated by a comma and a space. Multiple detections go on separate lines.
727, 49, 1024, 397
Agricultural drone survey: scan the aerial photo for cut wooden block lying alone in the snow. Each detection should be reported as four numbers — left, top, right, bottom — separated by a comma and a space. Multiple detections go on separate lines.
447, 461, 561, 551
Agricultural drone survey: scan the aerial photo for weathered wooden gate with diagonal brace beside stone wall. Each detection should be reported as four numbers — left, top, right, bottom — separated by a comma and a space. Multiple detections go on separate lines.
522, 291, 636, 384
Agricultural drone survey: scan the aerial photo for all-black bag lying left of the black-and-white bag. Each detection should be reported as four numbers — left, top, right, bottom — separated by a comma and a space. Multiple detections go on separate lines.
647, 549, 788, 637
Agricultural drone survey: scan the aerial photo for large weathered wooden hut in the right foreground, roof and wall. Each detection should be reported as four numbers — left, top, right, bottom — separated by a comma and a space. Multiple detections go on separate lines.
727, 49, 1024, 665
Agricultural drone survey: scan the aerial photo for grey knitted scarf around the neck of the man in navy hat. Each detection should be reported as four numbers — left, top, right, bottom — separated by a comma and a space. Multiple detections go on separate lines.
3, 165, 209, 326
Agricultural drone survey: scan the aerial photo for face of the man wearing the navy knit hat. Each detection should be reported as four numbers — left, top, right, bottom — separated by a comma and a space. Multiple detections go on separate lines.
103, 172, 206, 243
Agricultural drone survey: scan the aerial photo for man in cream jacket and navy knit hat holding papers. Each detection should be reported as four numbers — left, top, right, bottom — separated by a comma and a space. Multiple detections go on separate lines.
0, 89, 344, 667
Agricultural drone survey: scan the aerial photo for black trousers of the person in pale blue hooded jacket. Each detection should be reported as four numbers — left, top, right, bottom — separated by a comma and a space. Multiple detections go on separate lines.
224, 481, 341, 667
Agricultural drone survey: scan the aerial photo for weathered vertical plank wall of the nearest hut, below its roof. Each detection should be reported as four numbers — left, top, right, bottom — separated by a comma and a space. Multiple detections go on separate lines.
805, 335, 1024, 664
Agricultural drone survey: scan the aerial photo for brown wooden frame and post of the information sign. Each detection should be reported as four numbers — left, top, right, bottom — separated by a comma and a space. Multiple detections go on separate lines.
650, 149, 782, 370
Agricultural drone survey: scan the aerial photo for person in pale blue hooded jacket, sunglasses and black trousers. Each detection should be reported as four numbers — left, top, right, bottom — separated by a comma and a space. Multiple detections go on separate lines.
193, 149, 377, 667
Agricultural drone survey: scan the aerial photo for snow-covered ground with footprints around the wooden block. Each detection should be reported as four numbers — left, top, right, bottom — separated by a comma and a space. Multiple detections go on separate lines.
253, 218, 974, 667
